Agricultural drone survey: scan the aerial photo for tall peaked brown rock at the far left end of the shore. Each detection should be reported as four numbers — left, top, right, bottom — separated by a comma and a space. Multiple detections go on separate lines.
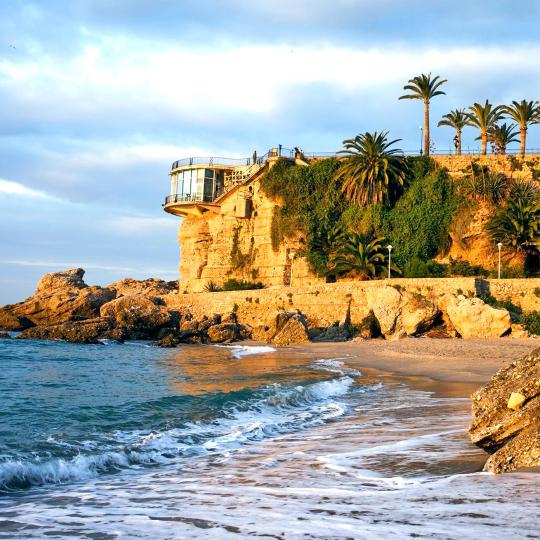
0, 268, 115, 330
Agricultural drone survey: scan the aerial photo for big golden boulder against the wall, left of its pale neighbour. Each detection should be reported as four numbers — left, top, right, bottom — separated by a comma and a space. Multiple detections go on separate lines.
366, 285, 440, 338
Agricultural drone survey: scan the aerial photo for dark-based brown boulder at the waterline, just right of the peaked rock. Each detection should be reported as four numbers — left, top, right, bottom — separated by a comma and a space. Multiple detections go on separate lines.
100, 294, 179, 339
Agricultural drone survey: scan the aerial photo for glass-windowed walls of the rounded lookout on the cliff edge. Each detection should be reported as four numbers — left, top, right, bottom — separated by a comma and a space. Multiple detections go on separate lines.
171, 168, 224, 202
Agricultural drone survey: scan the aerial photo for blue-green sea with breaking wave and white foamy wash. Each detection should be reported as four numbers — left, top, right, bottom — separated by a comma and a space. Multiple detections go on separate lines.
0, 339, 540, 540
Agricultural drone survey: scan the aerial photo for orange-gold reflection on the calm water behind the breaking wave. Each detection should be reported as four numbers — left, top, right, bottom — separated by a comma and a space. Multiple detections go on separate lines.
161, 345, 328, 395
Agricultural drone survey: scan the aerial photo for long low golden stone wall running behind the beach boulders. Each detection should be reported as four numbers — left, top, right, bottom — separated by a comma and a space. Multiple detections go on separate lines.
165, 278, 540, 327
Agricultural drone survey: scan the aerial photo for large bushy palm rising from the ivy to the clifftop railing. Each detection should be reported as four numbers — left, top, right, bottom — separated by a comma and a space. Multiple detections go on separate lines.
334, 131, 407, 207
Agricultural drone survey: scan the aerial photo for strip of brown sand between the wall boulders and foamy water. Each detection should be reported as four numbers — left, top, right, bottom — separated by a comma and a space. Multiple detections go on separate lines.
288, 338, 540, 397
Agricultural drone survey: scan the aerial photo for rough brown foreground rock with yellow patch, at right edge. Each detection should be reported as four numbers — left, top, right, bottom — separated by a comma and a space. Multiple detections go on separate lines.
469, 348, 540, 473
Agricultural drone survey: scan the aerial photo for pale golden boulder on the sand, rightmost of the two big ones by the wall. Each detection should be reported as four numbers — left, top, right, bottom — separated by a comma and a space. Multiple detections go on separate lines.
446, 295, 512, 339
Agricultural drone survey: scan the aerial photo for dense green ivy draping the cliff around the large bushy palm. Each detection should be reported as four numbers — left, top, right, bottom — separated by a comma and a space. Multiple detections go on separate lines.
261, 158, 461, 275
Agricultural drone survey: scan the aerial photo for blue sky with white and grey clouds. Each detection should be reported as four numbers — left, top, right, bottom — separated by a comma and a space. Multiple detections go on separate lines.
0, 0, 540, 305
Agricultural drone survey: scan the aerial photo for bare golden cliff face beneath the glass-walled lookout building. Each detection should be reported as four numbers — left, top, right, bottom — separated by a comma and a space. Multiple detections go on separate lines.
178, 175, 321, 292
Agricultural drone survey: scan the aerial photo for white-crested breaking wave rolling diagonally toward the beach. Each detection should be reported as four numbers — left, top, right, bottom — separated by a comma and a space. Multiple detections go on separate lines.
0, 376, 367, 491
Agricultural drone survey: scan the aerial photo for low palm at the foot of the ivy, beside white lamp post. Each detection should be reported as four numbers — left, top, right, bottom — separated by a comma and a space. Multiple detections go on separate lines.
328, 233, 399, 280
